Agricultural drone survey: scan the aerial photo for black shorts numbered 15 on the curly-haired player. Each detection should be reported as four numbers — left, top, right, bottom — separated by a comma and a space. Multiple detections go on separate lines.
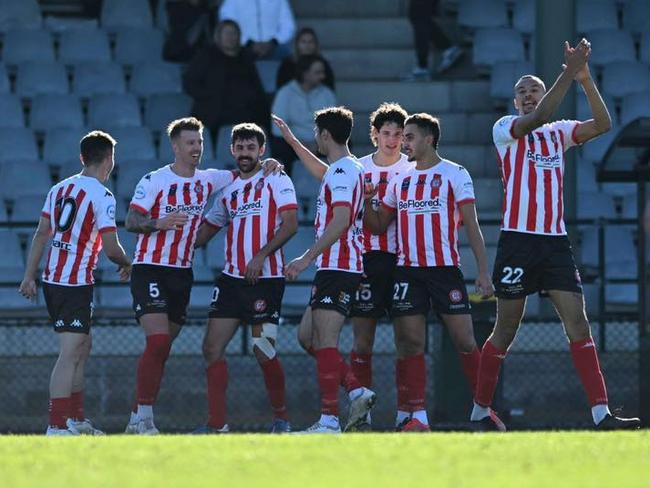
350, 251, 397, 318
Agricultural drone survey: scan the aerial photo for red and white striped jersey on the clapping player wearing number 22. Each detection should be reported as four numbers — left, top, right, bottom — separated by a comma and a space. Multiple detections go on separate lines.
492, 115, 580, 235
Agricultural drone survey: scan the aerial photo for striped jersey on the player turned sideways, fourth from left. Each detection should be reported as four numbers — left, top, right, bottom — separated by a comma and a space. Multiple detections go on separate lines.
314, 156, 363, 273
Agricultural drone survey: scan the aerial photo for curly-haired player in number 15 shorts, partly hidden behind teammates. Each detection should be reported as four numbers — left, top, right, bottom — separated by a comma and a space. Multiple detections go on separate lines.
275, 103, 414, 430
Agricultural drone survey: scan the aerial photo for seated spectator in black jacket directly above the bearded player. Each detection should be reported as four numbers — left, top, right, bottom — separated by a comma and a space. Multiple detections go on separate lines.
183, 20, 270, 143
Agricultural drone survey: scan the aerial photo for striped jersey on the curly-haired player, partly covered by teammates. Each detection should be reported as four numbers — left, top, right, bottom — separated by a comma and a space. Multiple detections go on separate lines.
359, 154, 415, 254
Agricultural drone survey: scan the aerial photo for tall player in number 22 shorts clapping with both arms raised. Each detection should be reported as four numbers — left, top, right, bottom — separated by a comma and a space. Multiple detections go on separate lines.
471, 39, 639, 429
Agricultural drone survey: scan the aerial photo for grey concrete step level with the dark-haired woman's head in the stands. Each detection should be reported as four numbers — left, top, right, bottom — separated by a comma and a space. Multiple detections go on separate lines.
298, 17, 413, 49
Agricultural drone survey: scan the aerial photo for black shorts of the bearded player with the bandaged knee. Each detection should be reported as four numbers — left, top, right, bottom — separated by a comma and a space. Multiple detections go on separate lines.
208, 273, 284, 325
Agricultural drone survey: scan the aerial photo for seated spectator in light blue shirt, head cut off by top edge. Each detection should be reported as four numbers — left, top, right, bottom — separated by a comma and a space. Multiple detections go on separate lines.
219, 0, 296, 60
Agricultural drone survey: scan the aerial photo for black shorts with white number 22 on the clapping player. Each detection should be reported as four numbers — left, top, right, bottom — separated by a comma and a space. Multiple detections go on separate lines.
492, 231, 582, 298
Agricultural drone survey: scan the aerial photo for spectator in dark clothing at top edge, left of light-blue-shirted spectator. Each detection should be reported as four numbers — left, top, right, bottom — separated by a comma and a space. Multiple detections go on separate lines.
163, 0, 217, 63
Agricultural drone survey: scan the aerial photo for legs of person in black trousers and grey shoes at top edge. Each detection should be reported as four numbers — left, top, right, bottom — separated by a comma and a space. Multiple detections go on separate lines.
405, 0, 463, 81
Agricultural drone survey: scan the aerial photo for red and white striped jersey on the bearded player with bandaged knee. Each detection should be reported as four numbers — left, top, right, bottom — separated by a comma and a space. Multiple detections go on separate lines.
205, 171, 298, 278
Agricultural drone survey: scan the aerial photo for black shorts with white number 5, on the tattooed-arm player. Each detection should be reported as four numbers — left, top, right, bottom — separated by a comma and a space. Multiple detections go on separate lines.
131, 264, 194, 325
